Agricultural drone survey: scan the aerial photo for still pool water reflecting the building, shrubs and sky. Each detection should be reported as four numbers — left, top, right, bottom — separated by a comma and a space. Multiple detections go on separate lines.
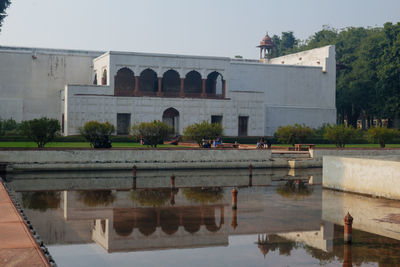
7, 169, 400, 267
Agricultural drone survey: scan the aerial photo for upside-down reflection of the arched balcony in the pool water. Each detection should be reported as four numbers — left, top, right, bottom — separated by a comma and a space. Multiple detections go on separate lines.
92, 204, 228, 252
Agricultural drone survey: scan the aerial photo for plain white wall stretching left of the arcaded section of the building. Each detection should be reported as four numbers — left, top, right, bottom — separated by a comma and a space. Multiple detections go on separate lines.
0, 47, 100, 121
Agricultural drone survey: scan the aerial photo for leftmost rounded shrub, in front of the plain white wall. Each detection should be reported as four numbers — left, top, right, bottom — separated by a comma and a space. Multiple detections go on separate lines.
21, 117, 60, 148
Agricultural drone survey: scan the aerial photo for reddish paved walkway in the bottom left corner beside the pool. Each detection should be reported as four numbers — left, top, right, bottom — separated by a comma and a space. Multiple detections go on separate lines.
0, 182, 50, 267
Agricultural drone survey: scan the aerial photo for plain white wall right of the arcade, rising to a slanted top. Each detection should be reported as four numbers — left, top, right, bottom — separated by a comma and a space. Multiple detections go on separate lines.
229, 46, 336, 135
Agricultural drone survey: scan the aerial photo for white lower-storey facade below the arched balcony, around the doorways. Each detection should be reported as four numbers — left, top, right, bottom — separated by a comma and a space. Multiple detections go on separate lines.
64, 85, 264, 136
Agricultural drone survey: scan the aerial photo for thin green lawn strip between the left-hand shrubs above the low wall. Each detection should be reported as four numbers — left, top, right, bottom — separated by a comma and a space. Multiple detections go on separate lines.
0, 142, 182, 148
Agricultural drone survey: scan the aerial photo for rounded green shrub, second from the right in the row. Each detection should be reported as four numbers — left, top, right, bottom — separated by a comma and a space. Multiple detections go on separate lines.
324, 124, 358, 148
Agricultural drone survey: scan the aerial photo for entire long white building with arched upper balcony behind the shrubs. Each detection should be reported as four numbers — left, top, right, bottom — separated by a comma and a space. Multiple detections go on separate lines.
0, 38, 336, 136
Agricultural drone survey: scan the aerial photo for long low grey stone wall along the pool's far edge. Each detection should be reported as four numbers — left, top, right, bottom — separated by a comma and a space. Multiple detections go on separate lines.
0, 149, 274, 172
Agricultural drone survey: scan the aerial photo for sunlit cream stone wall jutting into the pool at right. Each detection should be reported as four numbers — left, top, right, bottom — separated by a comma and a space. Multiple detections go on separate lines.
322, 156, 400, 199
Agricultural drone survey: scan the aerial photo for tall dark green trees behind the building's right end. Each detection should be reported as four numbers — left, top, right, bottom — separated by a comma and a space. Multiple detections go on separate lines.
271, 22, 400, 128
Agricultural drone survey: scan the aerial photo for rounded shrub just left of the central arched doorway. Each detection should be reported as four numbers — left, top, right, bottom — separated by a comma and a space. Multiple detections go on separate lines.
132, 120, 174, 147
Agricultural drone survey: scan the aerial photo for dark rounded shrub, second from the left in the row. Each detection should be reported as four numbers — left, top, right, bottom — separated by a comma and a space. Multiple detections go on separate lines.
79, 121, 115, 148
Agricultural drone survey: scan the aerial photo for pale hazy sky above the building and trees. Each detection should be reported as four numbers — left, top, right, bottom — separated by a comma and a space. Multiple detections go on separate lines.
0, 0, 400, 58
